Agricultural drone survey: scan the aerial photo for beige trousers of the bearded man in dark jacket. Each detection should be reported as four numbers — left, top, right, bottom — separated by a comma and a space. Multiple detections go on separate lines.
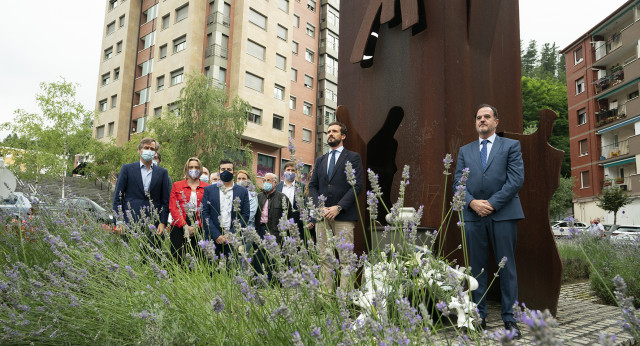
316, 220, 356, 290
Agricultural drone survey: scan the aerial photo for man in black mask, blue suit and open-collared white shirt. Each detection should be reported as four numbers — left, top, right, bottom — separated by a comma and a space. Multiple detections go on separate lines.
202, 159, 249, 254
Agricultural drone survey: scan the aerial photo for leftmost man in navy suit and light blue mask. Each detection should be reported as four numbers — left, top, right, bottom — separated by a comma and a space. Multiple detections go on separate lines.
113, 138, 171, 235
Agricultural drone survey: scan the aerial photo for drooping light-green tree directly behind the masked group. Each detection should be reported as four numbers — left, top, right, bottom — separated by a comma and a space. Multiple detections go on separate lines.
149, 73, 251, 181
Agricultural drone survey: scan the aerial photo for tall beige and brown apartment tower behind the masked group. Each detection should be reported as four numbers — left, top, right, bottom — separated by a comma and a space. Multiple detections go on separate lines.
94, 0, 340, 181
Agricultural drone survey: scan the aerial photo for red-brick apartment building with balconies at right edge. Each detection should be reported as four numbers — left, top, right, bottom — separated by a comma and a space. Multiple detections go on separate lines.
561, 0, 640, 224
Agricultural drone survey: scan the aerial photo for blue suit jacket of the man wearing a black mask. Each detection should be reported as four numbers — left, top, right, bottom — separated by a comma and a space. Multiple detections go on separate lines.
202, 184, 250, 240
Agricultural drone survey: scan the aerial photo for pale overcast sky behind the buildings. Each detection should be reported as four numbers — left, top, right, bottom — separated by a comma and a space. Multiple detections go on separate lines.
0, 0, 626, 139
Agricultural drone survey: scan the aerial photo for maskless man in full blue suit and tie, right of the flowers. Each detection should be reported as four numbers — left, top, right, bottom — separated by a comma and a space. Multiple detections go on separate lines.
454, 104, 524, 338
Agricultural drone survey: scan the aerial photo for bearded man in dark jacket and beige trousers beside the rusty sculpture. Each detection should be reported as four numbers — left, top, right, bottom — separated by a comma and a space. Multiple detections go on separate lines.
309, 121, 364, 290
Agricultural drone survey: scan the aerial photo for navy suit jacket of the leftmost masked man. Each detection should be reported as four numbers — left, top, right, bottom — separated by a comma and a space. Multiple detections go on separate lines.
113, 161, 171, 225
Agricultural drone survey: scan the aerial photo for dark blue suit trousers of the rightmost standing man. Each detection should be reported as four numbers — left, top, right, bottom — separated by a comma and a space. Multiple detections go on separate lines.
464, 217, 518, 322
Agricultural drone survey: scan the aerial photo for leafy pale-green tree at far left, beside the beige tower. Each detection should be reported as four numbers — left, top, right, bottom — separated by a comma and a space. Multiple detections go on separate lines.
2, 79, 94, 197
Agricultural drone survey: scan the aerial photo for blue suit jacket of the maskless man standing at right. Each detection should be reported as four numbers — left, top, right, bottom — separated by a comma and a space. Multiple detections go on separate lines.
454, 136, 524, 221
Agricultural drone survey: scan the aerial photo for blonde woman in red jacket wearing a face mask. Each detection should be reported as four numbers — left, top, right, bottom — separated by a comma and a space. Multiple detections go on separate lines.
169, 157, 209, 262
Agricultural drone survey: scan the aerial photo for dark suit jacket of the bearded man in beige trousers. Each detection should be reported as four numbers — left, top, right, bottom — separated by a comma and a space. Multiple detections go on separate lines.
309, 149, 364, 221
